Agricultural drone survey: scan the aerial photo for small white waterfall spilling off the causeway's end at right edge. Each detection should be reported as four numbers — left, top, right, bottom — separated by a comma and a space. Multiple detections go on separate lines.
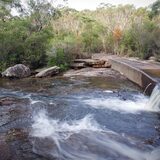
147, 84, 160, 111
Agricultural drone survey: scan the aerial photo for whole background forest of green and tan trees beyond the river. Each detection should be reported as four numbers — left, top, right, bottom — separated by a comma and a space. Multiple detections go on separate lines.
0, 0, 160, 71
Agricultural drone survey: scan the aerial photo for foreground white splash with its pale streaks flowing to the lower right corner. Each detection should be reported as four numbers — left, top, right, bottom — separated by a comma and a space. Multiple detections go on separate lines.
31, 110, 160, 160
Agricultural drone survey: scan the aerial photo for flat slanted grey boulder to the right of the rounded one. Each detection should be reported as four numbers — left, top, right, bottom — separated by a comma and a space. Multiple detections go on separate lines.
35, 66, 60, 78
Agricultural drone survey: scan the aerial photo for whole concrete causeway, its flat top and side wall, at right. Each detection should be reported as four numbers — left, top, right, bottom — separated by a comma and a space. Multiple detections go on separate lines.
92, 54, 160, 95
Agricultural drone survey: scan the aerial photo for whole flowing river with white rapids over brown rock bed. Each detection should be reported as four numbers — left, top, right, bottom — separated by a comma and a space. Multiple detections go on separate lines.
0, 77, 160, 160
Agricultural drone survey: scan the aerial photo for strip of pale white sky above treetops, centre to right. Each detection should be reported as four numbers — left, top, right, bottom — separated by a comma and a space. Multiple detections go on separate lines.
67, 0, 156, 10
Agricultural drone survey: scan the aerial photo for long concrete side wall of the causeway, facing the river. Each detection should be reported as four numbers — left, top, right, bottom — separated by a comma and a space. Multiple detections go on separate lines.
110, 59, 157, 95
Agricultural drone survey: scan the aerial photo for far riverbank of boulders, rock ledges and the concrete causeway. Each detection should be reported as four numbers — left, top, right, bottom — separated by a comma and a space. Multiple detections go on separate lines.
2, 53, 160, 95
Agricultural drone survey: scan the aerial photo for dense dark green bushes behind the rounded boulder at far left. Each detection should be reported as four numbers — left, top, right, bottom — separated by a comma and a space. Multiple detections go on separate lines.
0, 19, 52, 70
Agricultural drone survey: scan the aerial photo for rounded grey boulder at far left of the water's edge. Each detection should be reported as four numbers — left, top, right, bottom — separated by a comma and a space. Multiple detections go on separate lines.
2, 64, 31, 78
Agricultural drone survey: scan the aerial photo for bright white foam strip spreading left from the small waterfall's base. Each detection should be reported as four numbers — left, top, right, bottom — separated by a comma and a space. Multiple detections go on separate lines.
82, 96, 157, 114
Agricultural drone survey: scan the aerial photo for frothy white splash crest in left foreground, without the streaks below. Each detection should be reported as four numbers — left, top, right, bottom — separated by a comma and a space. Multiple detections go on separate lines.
32, 110, 101, 139
